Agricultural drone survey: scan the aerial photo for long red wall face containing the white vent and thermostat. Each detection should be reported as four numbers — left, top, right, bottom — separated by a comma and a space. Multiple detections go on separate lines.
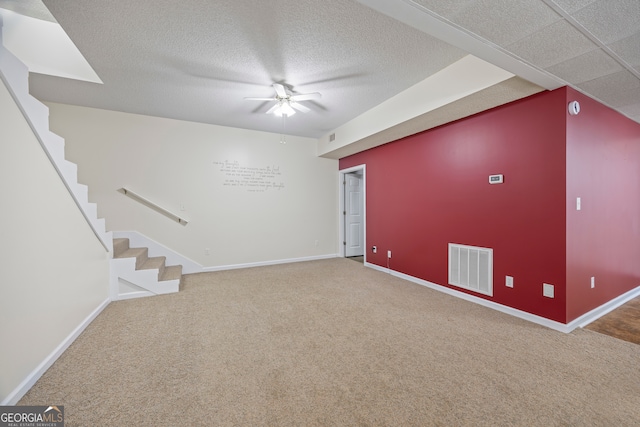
340, 88, 573, 323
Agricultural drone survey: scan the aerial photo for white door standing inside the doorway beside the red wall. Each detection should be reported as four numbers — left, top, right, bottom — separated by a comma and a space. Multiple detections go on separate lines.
344, 173, 364, 257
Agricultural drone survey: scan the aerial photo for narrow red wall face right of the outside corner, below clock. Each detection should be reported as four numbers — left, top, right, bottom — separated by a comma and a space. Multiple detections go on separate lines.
566, 88, 640, 322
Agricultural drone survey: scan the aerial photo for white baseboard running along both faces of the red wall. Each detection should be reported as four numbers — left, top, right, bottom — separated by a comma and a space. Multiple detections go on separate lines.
365, 262, 640, 333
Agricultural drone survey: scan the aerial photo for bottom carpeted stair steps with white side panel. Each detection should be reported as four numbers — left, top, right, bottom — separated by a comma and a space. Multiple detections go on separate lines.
111, 238, 182, 299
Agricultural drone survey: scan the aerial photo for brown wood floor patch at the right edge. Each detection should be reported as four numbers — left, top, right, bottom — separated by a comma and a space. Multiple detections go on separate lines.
585, 297, 640, 344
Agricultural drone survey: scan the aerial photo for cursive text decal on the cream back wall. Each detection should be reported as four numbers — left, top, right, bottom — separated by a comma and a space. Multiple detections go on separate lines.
213, 160, 284, 193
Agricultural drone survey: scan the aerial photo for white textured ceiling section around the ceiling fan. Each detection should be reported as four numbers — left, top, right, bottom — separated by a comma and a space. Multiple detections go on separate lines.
31, 0, 465, 137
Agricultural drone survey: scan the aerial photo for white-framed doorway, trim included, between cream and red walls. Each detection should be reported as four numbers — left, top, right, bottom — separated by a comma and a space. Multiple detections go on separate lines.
340, 165, 366, 263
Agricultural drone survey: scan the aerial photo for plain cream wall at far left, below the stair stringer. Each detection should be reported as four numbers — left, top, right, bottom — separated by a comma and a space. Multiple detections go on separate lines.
0, 83, 109, 403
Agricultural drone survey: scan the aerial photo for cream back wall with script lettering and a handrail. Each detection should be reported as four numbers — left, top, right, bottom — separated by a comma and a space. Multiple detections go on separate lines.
49, 104, 338, 268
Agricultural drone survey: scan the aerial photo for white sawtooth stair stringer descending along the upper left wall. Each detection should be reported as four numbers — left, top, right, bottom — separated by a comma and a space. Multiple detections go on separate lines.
0, 17, 113, 253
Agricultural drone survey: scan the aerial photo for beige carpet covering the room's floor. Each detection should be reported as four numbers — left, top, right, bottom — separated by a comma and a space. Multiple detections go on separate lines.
19, 258, 640, 427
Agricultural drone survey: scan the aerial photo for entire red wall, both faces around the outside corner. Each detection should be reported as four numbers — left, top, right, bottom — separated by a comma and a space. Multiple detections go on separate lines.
340, 88, 640, 324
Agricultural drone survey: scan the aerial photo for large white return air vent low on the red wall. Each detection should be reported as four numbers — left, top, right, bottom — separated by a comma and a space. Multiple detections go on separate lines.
449, 243, 493, 296
